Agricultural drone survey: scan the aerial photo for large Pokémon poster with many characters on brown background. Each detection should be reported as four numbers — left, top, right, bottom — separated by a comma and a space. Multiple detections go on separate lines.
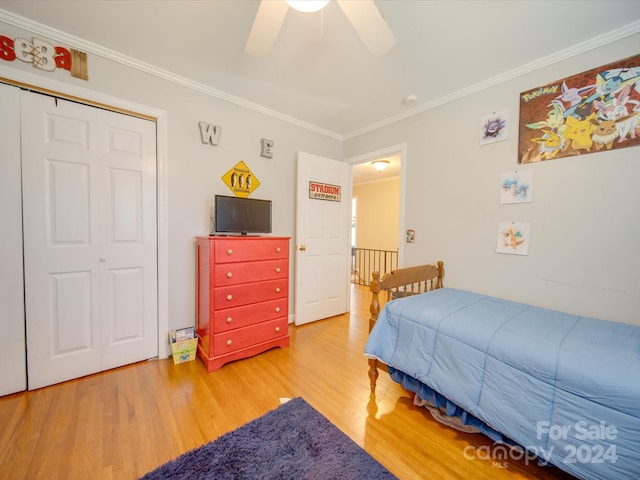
518, 55, 640, 163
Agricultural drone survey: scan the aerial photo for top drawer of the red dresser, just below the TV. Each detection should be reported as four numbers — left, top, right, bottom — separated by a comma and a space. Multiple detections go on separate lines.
213, 237, 289, 263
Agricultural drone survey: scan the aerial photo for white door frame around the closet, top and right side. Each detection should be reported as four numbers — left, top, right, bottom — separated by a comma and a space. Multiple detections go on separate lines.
0, 65, 170, 358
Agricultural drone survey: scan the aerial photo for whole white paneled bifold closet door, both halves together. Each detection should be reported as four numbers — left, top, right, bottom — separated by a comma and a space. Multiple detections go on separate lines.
21, 92, 158, 389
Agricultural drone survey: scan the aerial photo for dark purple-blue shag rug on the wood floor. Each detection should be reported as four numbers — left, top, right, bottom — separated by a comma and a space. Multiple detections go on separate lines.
141, 398, 396, 480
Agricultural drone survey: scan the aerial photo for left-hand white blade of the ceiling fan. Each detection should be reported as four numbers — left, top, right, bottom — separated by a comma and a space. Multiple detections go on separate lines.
244, 0, 289, 57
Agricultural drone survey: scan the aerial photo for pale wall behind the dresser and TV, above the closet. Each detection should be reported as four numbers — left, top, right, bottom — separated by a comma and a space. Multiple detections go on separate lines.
0, 22, 342, 352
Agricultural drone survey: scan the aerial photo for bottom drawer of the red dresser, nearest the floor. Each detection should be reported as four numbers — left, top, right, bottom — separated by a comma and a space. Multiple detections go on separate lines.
213, 317, 289, 355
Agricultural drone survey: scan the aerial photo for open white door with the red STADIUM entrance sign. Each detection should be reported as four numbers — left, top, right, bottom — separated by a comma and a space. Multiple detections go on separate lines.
295, 152, 351, 325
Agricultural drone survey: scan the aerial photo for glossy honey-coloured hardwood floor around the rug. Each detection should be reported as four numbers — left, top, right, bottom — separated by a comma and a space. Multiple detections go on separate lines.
0, 286, 572, 480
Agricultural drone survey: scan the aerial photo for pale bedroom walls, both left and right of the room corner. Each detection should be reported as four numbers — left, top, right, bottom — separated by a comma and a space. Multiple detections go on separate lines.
5, 18, 640, 338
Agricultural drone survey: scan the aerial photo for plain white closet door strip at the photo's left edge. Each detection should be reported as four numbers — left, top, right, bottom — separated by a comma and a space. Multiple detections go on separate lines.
0, 84, 27, 395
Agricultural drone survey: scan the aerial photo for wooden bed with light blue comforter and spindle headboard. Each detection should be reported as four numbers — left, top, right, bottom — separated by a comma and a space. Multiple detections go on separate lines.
365, 262, 640, 480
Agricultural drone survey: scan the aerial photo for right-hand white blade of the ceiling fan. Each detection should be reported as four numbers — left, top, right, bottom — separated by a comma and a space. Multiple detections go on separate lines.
337, 0, 396, 55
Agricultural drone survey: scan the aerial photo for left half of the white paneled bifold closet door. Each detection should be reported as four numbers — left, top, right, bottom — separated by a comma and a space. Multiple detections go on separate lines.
21, 92, 102, 390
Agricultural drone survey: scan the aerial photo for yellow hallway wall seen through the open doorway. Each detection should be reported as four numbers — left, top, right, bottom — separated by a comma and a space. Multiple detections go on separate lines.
353, 177, 400, 251
